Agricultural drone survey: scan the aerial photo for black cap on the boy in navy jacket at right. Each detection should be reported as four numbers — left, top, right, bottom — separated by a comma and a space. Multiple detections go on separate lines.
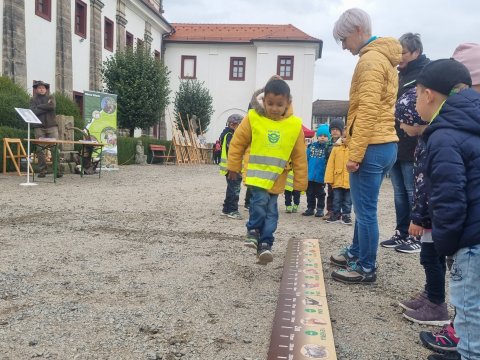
416, 59, 472, 96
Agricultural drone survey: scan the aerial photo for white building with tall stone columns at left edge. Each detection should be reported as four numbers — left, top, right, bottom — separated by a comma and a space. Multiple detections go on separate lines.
0, 0, 172, 115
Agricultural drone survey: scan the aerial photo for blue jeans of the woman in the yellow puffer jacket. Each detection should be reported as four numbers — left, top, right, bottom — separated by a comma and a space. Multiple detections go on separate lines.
349, 143, 397, 270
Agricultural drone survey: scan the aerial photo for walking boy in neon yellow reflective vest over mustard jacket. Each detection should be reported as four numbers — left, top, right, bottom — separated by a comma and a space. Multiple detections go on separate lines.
227, 79, 308, 264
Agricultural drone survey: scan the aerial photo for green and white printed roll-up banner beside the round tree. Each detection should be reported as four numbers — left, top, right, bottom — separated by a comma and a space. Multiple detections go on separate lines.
83, 91, 118, 169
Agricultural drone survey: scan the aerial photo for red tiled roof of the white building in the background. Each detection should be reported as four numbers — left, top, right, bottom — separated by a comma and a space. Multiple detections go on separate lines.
165, 23, 322, 43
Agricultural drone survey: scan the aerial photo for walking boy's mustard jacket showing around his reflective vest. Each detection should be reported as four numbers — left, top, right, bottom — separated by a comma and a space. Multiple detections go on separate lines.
227, 89, 308, 194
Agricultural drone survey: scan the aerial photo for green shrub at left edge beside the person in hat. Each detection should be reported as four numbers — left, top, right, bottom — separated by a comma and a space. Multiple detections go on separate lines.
0, 76, 30, 129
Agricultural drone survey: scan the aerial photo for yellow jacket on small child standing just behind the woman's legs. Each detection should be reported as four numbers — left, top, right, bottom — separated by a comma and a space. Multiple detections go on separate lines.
325, 139, 350, 189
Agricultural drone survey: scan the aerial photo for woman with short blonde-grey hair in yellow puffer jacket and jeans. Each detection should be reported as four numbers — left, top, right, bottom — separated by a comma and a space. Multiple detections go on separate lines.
330, 9, 402, 283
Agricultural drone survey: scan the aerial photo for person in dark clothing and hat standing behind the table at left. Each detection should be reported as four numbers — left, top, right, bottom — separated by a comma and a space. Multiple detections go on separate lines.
30, 80, 63, 177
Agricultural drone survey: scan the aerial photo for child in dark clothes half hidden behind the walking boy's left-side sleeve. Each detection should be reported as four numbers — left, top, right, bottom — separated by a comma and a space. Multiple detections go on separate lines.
220, 114, 243, 220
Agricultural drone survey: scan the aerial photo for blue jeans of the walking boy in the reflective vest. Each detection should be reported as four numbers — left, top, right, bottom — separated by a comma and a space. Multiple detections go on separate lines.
247, 186, 278, 246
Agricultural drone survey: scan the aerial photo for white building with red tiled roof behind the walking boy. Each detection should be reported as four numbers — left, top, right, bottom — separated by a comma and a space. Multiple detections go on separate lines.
164, 23, 322, 142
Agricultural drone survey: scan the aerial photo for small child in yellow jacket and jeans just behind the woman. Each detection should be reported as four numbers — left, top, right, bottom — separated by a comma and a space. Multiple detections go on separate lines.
325, 128, 352, 225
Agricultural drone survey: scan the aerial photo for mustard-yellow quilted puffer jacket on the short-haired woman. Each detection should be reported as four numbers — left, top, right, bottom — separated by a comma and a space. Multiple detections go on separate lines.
347, 38, 402, 163
